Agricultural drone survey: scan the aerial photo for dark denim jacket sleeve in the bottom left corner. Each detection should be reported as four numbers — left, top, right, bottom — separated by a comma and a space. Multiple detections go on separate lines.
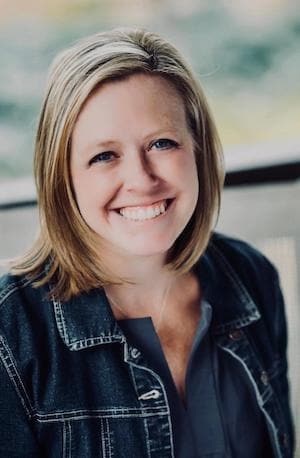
0, 360, 45, 458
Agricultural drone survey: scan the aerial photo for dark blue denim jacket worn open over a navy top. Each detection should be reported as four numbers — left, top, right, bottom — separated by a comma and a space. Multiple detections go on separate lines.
0, 234, 294, 458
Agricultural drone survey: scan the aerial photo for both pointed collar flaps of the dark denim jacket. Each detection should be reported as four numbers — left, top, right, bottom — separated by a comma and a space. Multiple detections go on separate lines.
53, 241, 260, 351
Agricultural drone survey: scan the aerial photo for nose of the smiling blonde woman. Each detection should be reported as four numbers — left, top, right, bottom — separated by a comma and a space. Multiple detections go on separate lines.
122, 151, 159, 192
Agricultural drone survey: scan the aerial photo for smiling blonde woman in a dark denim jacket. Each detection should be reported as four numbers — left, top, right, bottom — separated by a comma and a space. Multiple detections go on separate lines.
0, 29, 293, 458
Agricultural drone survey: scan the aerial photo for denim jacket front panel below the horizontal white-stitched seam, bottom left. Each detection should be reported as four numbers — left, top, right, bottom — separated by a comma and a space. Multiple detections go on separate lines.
36, 409, 148, 458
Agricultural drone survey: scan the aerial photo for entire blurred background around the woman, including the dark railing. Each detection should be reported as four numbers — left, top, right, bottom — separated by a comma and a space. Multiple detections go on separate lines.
0, 0, 300, 457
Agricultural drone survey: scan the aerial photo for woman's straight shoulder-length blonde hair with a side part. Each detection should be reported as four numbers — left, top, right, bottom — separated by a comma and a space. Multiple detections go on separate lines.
12, 29, 224, 300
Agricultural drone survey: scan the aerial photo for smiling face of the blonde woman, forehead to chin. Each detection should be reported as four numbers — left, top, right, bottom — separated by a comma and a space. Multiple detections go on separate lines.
71, 74, 198, 259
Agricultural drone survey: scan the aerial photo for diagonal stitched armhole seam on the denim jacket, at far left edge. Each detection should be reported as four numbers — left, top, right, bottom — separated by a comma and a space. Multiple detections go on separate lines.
0, 336, 34, 418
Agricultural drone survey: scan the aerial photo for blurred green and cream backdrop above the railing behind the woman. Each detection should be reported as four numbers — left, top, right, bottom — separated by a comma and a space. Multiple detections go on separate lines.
0, 0, 300, 181
